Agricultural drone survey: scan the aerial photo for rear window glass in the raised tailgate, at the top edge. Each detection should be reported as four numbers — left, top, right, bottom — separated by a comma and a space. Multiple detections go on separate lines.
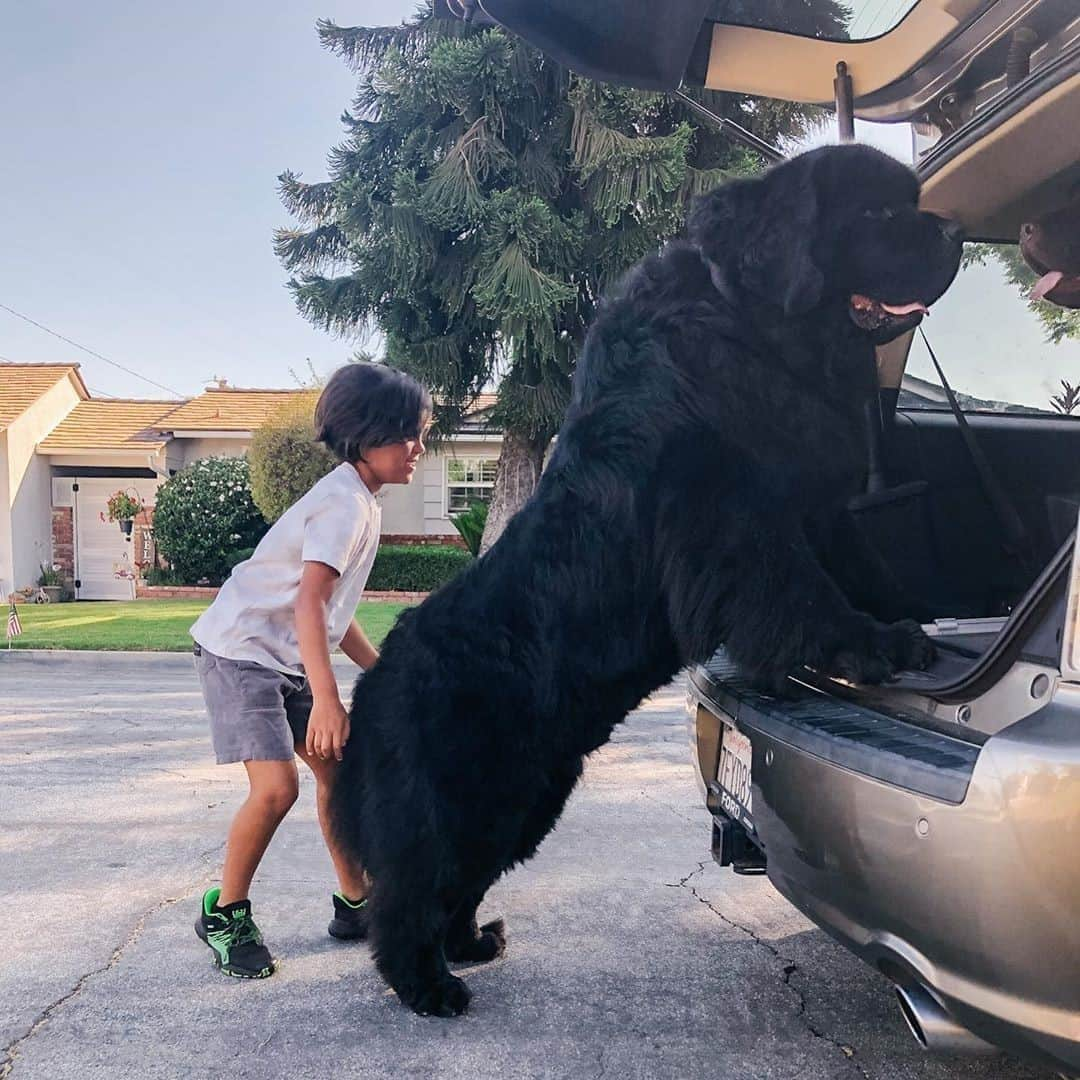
708, 0, 918, 41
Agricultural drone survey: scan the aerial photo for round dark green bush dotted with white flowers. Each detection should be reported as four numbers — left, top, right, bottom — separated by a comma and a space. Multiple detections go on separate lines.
153, 458, 267, 585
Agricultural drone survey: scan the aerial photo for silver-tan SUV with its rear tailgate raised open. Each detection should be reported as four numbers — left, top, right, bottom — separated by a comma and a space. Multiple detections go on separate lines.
444, 0, 1080, 1072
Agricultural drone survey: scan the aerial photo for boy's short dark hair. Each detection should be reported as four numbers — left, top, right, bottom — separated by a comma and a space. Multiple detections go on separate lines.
315, 364, 431, 463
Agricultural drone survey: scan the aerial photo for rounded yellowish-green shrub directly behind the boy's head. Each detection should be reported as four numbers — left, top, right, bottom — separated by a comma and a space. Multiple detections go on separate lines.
247, 391, 338, 522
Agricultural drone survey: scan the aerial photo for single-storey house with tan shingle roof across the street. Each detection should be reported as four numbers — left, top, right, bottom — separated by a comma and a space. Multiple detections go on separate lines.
0, 363, 502, 599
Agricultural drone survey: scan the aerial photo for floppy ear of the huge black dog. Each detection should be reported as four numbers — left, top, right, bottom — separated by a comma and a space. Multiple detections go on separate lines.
688, 158, 825, 315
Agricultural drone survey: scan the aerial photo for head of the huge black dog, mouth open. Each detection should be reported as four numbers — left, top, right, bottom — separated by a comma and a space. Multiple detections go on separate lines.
689, 146, 962, 343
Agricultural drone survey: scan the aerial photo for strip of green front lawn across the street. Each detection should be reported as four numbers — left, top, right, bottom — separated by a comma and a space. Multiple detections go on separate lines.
6, 600, 406, 652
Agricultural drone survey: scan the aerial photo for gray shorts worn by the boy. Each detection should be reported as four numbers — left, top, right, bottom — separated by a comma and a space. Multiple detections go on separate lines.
194, 645, 311, 765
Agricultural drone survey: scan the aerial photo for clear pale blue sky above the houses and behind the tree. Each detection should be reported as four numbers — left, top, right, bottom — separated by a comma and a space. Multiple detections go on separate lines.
0, 0, 1080, 404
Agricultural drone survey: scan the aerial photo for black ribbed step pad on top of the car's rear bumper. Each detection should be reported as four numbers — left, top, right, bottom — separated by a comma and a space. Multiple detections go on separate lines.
690, 650, 980, 804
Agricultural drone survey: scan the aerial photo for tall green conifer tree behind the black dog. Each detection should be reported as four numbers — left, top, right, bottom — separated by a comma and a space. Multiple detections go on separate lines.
275, 0, 838, 548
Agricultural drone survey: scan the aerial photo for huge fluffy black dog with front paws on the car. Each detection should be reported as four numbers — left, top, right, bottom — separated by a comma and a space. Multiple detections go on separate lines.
334, 147, 960, 1016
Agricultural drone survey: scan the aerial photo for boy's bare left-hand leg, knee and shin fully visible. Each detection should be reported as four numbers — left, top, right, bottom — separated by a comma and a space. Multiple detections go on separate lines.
217, 761, 299, 907
